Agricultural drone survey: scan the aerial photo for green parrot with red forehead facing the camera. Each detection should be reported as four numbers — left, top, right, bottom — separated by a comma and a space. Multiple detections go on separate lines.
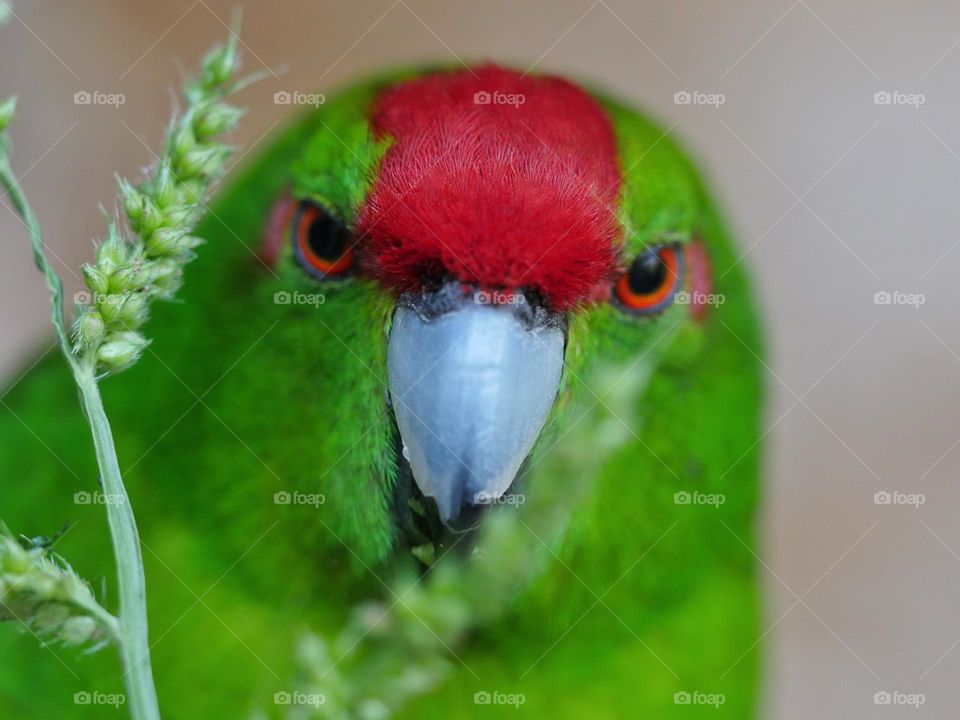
0, 64, 765, 720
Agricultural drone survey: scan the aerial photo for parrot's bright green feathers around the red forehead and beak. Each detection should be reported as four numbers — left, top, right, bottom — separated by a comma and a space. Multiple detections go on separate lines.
0, 69, 761, 720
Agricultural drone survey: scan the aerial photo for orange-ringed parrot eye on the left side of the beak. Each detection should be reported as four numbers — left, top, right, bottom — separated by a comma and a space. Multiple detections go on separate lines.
293, 202, 353, 280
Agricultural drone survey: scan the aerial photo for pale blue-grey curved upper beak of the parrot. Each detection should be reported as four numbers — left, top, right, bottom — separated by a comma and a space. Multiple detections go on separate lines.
387, 286, 565, 523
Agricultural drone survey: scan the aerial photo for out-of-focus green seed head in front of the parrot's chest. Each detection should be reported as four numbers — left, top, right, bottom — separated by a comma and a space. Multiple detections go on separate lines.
270, 363, 648, 720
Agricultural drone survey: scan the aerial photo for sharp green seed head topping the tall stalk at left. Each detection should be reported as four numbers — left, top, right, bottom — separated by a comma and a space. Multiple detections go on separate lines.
56, 26, 244, 373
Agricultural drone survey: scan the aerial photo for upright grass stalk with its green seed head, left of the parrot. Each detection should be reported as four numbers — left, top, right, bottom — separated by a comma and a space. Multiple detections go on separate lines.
0, 15, 249, 720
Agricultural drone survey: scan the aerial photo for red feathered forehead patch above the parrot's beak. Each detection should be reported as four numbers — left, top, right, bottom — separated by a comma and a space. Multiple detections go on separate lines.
358, 66, 621, 310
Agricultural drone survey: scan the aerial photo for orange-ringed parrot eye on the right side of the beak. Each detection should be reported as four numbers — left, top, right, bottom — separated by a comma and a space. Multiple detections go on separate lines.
613, 245, 683, 315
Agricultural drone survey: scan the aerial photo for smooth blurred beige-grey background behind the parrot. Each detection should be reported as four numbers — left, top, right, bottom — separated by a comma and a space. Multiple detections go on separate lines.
0, 0, 960, 719
